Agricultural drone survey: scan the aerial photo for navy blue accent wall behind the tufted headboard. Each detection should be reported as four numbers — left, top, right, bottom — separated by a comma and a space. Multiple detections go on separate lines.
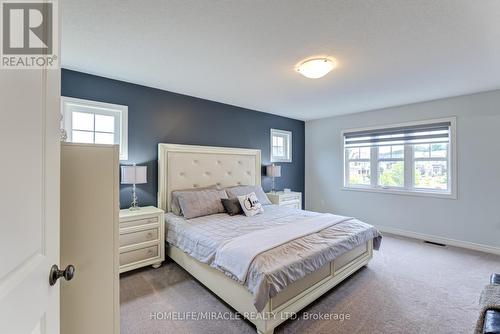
61, 69, 304, 208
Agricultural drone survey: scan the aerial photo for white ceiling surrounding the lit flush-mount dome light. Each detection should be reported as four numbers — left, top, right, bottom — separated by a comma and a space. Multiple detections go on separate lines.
61, 0, 500, 120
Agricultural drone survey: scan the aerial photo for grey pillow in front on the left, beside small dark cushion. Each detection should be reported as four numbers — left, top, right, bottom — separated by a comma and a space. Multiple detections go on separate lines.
179, 189, 227, 219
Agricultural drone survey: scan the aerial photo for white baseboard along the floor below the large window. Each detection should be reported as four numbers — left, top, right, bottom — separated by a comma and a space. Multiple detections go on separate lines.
376, 226, 500, 255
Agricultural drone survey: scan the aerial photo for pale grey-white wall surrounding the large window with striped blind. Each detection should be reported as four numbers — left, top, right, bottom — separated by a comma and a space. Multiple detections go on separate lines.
305, 90, 500, 247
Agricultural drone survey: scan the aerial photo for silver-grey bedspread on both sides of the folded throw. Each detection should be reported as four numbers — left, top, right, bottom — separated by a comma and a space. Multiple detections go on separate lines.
165, 205, 381, 311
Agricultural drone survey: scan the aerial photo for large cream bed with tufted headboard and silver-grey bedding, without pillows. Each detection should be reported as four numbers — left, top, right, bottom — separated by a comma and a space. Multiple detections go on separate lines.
158, 144, 381, 334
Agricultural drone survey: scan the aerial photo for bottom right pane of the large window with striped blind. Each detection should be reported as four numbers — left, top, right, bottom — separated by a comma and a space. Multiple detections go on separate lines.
415, 161, 448, 190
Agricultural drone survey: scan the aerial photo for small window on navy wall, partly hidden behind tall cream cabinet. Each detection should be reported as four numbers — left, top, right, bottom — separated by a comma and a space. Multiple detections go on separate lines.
61, 97, 128, 160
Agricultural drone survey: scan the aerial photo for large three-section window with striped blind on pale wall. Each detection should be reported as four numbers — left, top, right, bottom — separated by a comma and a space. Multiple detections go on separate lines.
343, 118, 456, 197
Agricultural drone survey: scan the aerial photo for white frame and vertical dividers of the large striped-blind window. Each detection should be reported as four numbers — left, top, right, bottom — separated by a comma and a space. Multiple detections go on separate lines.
341, 116, 458, 199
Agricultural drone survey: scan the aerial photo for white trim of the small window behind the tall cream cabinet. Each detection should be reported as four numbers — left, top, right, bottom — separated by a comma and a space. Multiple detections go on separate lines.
61, 96, 128, 161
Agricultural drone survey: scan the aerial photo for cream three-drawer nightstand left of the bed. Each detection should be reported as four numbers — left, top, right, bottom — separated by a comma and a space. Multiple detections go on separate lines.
120, 206, 165, 273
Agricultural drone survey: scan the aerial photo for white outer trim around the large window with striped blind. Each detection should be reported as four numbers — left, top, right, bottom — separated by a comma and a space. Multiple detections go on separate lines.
340, 116, 458, 199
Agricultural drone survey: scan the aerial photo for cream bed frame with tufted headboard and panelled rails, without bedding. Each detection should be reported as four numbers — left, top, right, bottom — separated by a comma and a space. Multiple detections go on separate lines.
158, 144, 373, 334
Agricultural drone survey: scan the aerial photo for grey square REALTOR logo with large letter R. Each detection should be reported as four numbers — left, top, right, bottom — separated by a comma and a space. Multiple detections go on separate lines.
0, 0, 59, 69
